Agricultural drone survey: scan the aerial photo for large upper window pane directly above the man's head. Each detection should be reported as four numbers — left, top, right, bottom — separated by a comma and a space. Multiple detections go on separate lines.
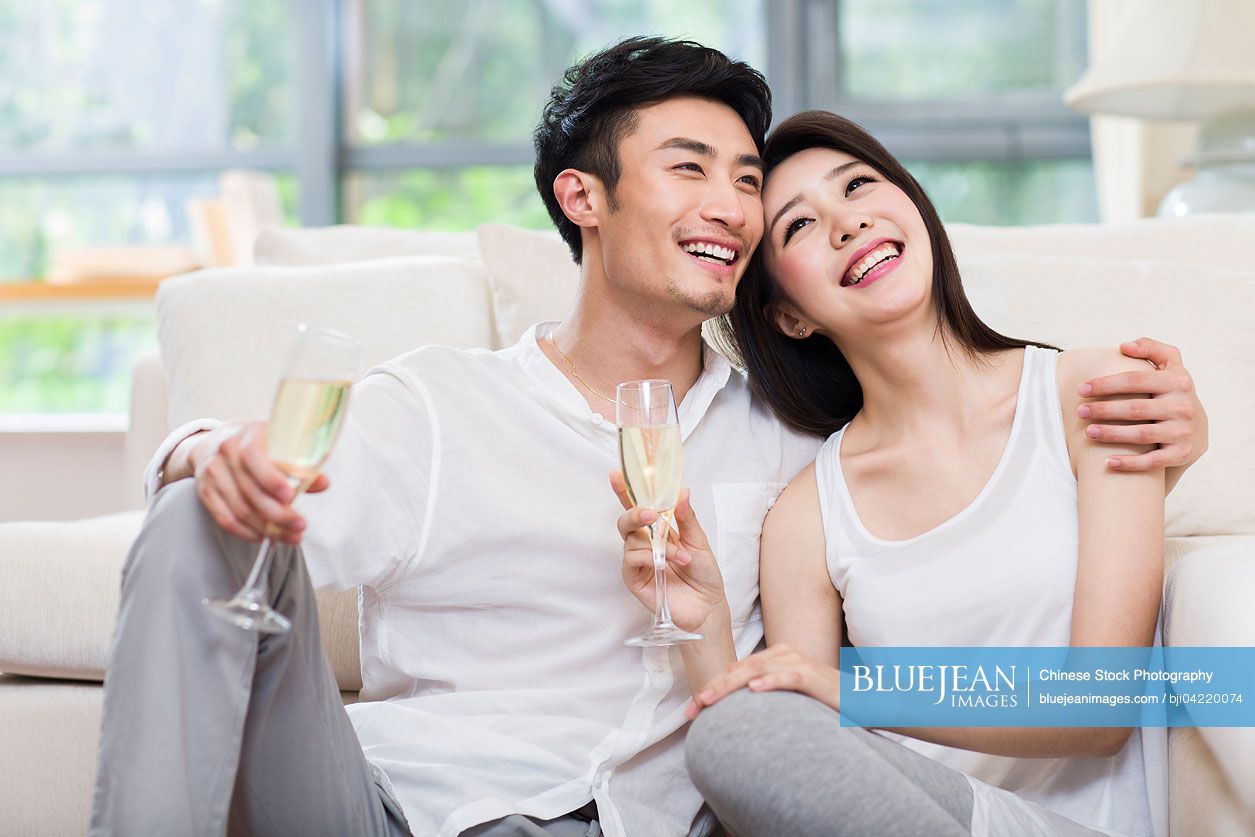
345, 0, 767, 146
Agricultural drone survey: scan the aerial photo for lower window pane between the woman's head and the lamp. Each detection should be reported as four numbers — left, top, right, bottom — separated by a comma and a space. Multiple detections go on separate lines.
907, 159, 1098, 226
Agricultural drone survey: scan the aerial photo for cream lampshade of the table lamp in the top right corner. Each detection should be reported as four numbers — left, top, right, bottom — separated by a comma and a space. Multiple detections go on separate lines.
1063, 0, 1255, 119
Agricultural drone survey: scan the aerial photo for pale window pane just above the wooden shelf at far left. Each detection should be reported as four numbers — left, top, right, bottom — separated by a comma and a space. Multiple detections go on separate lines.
0, 173, 296, 281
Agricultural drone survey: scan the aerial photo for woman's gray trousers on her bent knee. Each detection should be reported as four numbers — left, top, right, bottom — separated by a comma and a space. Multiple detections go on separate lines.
685, 689, 973, 837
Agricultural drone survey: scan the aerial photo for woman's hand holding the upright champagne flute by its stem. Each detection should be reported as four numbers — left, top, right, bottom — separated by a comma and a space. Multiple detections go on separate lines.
610, 471, 729, 632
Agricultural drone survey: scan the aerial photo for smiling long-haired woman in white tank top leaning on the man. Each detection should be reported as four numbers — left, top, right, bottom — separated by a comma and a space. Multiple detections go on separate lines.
621, 112, 1166, 834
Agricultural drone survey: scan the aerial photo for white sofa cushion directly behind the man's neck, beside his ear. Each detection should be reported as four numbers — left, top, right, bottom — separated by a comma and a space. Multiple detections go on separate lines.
478, 223, 580, 346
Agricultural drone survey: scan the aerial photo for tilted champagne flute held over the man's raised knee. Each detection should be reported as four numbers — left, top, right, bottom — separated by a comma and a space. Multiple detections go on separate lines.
205, 325, 361, 634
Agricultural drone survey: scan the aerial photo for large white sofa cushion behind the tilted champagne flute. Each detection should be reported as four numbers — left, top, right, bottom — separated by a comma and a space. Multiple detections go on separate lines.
157, 256, 493, 427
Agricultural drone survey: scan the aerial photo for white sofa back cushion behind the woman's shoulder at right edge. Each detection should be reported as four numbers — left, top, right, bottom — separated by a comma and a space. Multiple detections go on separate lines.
960, 252, 1255, 536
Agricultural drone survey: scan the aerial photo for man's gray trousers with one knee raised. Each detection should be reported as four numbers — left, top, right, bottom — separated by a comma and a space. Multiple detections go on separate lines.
90, 479, 600, 837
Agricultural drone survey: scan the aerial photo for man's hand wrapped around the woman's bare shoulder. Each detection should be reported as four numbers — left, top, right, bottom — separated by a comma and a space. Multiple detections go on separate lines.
1077, 338, 1207, 471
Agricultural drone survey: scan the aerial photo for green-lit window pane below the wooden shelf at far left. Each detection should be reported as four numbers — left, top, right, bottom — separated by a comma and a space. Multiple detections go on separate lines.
0, 310, 157, 413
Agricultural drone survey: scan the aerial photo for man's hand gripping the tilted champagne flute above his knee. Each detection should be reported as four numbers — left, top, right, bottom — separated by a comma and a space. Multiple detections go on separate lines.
187, 422, 330, 543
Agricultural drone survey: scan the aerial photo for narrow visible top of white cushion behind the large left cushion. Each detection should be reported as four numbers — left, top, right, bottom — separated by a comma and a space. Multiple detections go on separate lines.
252, 225, 479, 265
